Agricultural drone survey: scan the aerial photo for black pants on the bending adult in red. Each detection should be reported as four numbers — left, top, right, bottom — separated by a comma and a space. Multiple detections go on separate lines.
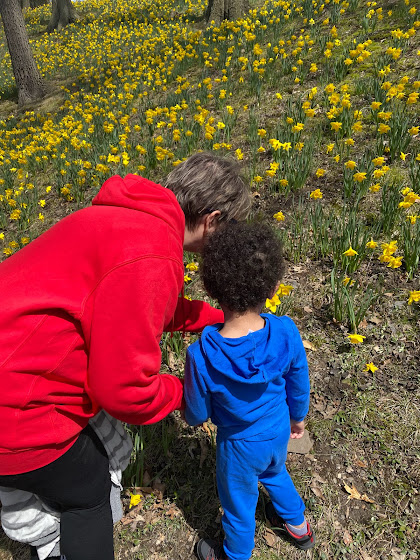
0, 426, 114, 560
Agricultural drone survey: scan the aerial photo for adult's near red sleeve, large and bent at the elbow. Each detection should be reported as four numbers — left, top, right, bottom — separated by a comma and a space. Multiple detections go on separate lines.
86, 258, 183, 424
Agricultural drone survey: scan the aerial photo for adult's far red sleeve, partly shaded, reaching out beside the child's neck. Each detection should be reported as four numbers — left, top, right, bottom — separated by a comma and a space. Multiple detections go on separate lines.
166, 296, 224, 332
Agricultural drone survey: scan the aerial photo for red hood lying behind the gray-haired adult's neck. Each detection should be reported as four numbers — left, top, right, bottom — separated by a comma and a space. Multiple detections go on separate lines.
92, 175, 185, 239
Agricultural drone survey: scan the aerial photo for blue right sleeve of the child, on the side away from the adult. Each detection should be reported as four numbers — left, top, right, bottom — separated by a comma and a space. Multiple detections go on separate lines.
284, 319, 310, 422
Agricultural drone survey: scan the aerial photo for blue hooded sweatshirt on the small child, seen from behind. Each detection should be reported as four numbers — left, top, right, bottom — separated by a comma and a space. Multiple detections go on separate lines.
184, 313, 309, 439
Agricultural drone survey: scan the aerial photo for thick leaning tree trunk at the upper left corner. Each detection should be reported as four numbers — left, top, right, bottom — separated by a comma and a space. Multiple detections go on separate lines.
0, 0, 47, 105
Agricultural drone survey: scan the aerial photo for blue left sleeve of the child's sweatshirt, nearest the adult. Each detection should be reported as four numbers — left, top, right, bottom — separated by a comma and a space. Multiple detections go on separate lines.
184, 349, 211, 426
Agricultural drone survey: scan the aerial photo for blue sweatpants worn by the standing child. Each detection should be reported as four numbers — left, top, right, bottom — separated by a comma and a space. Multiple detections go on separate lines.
216, 426, 305, 560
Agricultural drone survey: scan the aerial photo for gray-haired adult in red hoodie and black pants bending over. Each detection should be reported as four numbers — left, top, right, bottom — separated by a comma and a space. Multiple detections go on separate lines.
0, 153, 250, 560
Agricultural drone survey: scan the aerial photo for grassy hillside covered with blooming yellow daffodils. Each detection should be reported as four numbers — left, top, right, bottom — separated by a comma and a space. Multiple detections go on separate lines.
0, 0, 420, 560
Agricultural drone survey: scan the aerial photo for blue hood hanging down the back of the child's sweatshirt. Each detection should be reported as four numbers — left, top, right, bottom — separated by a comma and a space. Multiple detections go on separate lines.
200, 314, 292, 384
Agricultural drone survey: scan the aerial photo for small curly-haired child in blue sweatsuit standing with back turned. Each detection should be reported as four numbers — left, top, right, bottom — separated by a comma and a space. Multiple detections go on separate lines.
184, 224, 315, 560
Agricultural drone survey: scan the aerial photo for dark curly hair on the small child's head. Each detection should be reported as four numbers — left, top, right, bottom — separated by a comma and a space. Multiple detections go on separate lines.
201, 223, 284, 313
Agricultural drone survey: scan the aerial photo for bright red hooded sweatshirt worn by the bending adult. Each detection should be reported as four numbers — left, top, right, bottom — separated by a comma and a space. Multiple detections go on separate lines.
0, 175, 223, 475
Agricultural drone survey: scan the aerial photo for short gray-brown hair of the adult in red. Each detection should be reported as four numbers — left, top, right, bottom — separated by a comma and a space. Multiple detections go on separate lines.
163, 152, 251, 230
